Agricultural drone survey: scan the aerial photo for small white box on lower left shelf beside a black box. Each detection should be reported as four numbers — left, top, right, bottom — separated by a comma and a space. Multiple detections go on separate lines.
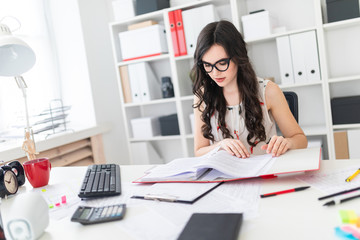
131, 117, 160, 139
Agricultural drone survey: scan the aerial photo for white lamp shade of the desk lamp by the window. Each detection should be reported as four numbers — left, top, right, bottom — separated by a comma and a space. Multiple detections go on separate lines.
0, 24, 36, 77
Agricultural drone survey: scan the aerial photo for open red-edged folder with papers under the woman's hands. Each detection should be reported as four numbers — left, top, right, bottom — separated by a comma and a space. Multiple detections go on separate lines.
133, 148, 321, 183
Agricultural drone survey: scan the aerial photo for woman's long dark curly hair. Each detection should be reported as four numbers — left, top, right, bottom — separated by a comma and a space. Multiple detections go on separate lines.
191, 20, 266, 146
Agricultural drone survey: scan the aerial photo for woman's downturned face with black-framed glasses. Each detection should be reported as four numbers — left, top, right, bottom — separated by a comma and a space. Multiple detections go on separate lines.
201, 44, 238, 87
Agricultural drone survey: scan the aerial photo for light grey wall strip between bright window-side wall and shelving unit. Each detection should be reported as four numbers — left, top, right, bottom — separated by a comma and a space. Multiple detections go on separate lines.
76, 0, 130, 164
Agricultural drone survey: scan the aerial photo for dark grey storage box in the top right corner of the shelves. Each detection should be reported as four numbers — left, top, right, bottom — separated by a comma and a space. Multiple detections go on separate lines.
326, 0, 360, 23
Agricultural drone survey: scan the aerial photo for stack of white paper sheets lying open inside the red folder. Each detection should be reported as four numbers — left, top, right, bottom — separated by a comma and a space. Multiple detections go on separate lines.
134, 148, 273, 182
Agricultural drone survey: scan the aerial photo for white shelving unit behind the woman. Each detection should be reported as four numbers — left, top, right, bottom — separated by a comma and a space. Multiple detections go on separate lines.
110, 0, 360, 163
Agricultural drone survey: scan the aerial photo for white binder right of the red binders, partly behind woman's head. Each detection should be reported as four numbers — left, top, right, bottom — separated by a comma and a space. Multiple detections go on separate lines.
182, 4, 217, 55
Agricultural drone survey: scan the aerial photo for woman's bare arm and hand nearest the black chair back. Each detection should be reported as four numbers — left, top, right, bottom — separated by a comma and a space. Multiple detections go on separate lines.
263, 82, 307, 156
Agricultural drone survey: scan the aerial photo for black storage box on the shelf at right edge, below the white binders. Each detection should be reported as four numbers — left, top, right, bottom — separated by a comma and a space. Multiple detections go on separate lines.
331, 96, 360, 124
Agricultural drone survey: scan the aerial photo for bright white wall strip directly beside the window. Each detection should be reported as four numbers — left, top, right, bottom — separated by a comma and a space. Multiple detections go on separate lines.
44, 0, 96, 130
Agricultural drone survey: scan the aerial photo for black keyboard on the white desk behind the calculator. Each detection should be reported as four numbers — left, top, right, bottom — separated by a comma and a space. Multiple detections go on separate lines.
78, 164, 121, 198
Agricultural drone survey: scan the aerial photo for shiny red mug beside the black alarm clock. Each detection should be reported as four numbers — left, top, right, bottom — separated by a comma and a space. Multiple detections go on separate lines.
23, 158, 51, 188
